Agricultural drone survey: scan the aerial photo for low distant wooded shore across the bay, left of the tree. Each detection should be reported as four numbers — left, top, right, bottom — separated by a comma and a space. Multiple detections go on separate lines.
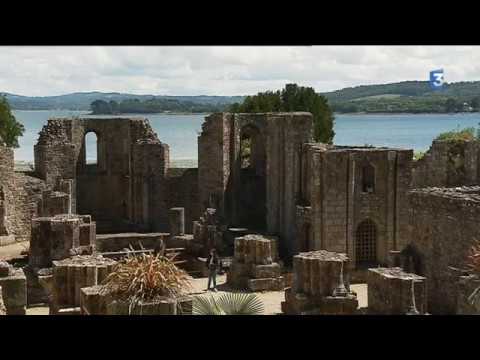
0, 91, 244, 111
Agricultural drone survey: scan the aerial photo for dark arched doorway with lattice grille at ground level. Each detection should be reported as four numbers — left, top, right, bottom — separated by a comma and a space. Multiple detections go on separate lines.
355, 219, 377, 267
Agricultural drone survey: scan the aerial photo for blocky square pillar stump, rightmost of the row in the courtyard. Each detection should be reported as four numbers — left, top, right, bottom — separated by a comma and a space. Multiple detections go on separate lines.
367, 267, 427, 315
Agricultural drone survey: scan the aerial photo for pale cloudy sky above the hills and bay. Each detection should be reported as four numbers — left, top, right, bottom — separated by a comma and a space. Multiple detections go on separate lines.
0, 46, 480, 96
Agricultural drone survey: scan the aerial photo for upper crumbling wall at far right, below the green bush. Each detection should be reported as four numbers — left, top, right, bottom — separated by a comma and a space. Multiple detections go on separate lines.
412, 140, 480, 188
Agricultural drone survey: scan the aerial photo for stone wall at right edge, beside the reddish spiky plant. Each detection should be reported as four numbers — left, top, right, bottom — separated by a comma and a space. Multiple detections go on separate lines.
408, 186, 480, 314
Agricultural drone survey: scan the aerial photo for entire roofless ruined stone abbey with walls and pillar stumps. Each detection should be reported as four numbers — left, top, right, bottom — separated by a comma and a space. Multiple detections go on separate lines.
0, 112, 480, 314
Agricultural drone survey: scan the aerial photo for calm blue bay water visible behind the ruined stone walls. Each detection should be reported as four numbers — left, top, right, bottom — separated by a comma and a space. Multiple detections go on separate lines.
13, 110, 480, 167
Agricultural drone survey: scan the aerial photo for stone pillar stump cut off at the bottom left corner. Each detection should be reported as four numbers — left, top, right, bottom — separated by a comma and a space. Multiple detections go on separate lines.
0, 261, 27, 315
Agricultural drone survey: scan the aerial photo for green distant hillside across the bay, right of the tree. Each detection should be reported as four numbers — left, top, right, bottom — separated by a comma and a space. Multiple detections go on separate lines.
322, 81, 480, 113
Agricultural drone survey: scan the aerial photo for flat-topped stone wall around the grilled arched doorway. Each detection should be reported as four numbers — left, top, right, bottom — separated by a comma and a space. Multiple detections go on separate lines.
295, 143, 412, 267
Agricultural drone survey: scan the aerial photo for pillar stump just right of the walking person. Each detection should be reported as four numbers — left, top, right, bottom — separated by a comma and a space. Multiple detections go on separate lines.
227, 235, 284, 291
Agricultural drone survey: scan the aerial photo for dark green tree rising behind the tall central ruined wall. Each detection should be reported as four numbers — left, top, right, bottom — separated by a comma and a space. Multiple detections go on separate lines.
229, 84, 335, 143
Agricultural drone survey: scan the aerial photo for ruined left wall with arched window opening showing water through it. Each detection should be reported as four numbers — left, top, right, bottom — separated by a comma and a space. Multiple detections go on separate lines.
34, 118, 169, 233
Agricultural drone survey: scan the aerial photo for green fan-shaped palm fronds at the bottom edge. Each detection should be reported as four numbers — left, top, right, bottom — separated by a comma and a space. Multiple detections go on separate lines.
193, 293, 264, 315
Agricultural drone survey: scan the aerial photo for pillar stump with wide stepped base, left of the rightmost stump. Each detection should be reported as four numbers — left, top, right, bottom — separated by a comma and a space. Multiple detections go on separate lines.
282, 250, 358, 315
